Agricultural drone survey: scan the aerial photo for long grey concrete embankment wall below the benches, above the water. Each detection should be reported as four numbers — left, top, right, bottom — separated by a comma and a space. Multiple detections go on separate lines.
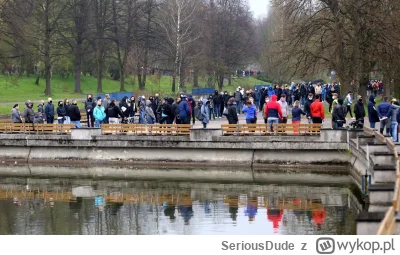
0, 130, 351, 168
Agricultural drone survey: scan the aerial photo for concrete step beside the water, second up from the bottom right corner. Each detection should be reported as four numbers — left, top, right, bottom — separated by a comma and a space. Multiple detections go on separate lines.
369, 183, 395, 206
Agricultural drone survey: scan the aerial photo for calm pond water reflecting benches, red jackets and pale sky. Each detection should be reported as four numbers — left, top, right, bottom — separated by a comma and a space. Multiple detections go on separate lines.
0, 177, 362, 235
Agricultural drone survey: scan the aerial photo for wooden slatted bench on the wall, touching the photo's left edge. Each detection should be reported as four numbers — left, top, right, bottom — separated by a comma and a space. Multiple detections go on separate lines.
0, 123, 74, 135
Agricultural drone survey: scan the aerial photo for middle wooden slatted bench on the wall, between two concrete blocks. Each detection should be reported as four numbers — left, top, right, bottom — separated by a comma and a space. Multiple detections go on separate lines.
101, 124, 192, 136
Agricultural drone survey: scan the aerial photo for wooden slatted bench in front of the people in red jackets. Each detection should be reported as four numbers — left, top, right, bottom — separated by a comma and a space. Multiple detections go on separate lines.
221, 124, 322, 136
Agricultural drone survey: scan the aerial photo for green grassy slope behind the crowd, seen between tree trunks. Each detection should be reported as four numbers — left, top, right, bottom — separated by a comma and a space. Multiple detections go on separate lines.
0, 75, 263, 114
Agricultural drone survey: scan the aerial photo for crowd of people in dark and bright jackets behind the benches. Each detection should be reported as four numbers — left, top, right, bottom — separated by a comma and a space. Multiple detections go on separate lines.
7, 81, 400, 142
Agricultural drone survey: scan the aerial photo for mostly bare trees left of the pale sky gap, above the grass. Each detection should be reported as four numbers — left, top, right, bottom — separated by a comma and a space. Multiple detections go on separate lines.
0, 0, 257, 95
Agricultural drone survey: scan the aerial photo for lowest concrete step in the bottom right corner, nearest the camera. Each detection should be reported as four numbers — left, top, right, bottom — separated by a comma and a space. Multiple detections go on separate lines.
356, 210, 400, 235
